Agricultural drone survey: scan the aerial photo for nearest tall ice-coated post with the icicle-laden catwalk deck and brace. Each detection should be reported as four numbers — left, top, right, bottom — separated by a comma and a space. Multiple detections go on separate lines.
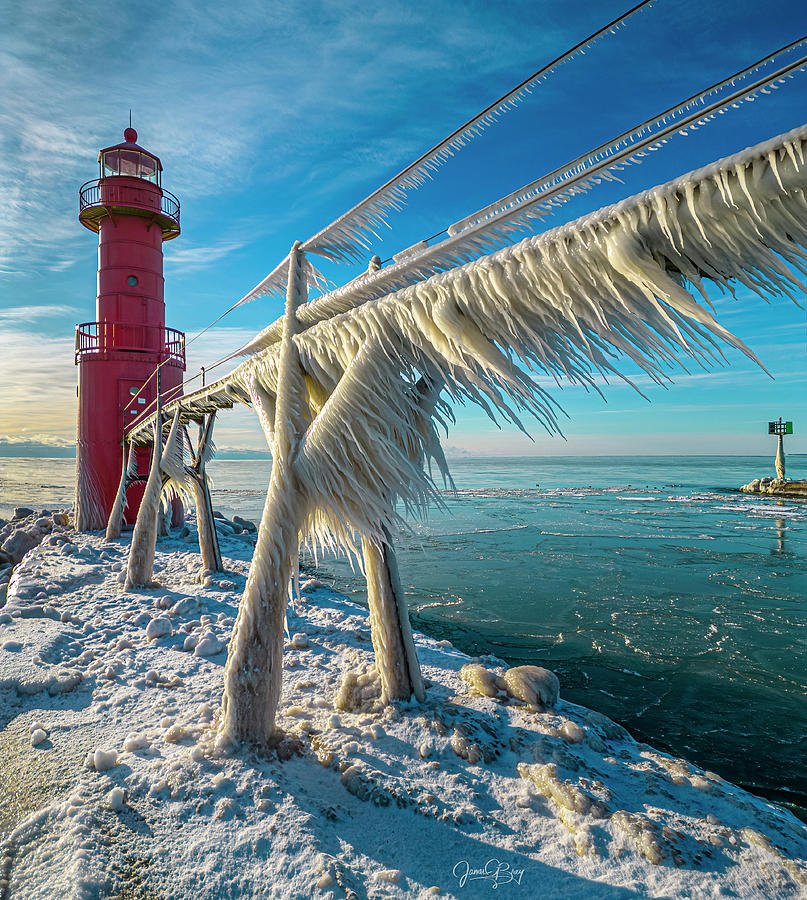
129, 123, 807, 741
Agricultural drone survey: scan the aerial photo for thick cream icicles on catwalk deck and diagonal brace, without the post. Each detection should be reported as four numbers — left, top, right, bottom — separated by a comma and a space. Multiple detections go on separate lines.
224, 129, 807, 560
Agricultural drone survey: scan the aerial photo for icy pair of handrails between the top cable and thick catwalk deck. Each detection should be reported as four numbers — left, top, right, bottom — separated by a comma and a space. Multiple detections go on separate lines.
234, 38, 807, 355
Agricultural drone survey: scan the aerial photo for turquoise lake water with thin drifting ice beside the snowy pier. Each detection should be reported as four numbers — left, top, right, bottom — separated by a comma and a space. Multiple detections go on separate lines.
0, 456, 807, 815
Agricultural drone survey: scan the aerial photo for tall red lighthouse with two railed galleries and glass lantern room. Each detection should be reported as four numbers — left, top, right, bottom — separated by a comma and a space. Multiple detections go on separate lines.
76, 128, 185, 530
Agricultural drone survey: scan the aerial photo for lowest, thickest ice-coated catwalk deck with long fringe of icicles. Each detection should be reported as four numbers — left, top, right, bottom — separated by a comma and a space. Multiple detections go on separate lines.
130, 126, 807, 478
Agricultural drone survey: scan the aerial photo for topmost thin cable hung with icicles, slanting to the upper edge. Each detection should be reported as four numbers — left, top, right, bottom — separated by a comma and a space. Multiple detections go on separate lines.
226, 0, 656, 308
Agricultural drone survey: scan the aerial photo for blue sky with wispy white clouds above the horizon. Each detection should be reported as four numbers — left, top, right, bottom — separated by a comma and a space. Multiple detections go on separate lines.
0, 0, 807, 460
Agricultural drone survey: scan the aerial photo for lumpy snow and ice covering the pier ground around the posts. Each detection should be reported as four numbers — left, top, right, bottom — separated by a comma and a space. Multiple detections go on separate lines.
0, 522, 807, 900
